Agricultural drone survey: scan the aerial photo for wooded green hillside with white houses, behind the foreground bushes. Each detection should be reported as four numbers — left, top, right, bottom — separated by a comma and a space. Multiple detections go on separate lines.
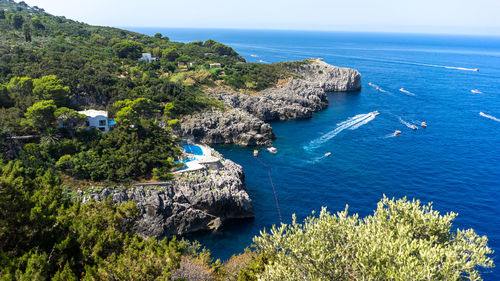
0, 0, 304, 182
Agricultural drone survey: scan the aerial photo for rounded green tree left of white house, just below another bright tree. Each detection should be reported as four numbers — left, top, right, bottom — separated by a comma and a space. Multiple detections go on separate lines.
23, 100, 57, 130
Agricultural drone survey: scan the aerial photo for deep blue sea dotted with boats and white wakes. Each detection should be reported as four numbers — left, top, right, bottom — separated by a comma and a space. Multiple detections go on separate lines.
131, 28, 500, 280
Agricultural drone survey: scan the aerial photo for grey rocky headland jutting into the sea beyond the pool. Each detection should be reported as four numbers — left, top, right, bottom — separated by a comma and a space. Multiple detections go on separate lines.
178, 59, 361, 146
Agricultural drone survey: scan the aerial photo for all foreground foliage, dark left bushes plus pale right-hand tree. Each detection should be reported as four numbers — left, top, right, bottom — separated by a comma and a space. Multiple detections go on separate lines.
0, 161, 493, 281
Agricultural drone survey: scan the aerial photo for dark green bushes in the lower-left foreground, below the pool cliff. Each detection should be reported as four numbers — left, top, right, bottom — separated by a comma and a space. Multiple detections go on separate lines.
0, 161, 211, 280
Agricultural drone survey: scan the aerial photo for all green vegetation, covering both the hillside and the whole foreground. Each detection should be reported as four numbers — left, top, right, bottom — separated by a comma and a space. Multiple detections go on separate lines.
0, 0, 493, 280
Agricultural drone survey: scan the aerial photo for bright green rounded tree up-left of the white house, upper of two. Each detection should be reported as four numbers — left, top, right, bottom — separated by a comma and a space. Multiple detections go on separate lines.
33, 75, 70, 106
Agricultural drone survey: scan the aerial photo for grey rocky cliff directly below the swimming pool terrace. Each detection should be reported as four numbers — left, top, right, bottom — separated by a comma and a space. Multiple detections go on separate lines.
80, 154, 254, 237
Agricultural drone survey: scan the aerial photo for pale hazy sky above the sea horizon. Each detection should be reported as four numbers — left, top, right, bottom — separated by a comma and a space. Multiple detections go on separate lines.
24, 0, 500, 36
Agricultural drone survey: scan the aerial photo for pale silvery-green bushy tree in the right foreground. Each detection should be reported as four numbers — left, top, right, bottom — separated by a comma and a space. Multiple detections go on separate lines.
254, 197, 493, 280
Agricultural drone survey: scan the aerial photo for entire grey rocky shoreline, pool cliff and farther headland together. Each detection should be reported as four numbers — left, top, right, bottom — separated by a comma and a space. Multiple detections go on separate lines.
79, 59, 361, 237
